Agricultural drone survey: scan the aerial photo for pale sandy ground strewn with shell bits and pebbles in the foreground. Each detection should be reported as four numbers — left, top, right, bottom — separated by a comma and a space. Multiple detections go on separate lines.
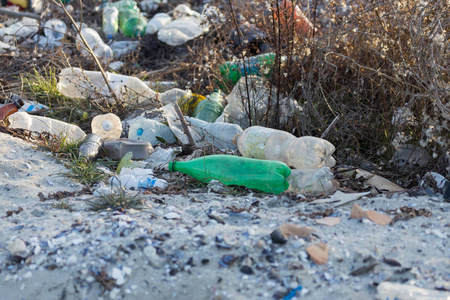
0, 133, 450, 299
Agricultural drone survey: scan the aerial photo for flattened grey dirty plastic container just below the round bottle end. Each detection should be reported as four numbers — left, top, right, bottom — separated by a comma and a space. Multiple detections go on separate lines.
102, 139, 154, 159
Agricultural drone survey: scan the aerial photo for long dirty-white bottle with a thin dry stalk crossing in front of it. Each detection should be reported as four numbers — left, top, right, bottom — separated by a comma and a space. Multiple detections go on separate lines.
57, 68, 158, 104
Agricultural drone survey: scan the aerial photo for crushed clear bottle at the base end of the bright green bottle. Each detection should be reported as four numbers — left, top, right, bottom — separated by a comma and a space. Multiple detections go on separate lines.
286, 167, 334, 194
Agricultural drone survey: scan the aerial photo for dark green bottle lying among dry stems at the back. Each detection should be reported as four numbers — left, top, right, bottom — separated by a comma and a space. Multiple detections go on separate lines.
219, 52, 275, 91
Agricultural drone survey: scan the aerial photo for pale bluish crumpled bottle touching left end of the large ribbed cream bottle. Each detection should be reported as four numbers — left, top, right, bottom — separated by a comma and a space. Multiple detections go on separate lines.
186, 117, 242, 150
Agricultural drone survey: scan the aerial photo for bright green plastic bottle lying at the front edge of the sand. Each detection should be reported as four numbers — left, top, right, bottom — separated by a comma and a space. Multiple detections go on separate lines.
169, 155, 291, 194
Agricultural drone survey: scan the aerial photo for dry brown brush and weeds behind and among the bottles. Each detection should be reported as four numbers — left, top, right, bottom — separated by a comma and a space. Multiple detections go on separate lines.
0, 0, 450, 187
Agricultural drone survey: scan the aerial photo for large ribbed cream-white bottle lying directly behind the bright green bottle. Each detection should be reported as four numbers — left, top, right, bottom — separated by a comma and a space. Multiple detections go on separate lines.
237, 126, 336, 169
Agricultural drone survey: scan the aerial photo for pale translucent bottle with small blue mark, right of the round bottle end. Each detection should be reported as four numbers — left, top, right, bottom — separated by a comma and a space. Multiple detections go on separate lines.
128, 118, 176, 146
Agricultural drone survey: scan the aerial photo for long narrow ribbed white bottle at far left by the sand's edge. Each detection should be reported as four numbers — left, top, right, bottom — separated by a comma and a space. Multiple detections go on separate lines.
9, 111, 86, 143
